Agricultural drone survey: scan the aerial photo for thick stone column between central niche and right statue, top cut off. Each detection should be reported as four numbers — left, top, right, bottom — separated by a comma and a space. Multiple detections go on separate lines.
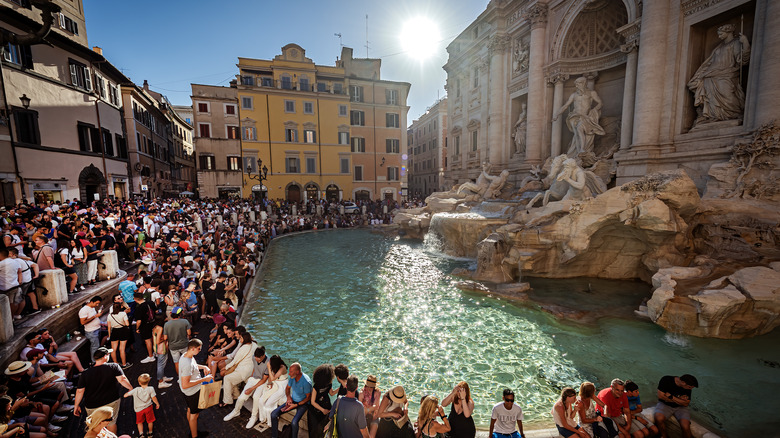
632, 1, 670, 145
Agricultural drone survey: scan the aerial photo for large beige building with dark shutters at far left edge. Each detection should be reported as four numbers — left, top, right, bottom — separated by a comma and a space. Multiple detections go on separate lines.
0, 0, 129, 205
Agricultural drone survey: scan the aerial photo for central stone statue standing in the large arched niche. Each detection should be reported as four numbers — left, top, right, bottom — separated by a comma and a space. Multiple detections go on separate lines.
553, 76, 605, 157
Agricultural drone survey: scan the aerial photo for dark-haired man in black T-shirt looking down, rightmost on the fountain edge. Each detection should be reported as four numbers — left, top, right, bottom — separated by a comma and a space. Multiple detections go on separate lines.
655, 374, 699, 438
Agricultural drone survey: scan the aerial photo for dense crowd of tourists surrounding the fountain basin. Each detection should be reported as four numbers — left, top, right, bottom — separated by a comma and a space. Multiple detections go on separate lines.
0, 199, 698, 438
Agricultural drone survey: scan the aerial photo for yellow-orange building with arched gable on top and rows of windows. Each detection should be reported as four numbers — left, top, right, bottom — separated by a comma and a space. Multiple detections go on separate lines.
235, 44, 353, 201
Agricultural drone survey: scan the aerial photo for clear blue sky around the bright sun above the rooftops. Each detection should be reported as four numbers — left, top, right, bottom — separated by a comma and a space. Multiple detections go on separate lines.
84, 0, 488, 124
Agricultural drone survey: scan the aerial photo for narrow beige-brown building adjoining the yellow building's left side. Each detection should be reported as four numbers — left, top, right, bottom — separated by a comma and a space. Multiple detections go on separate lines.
192, 82, 242, 198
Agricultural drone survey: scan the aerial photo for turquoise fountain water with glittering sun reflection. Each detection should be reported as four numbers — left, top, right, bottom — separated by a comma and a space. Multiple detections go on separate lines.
242, 230, 780, 437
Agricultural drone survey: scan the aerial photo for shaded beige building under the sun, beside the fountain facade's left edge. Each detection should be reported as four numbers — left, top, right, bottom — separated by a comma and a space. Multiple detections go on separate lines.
408, 97, 450, 198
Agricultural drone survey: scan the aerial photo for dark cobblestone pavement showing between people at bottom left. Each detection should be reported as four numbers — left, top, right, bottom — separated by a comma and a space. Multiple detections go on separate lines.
59, 320, 271, 438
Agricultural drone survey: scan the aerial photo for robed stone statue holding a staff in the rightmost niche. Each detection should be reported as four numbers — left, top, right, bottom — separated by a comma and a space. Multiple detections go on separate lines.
688, 24, 750, 126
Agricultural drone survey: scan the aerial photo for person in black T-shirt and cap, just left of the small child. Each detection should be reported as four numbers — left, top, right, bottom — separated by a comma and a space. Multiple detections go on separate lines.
73, 347, 133, 433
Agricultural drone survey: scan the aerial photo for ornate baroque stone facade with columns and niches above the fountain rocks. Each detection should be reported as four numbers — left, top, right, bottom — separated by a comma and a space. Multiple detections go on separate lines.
444, 0, 780, 191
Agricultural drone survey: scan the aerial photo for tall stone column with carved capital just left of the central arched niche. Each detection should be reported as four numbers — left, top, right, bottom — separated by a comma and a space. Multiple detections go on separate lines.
524, 3, 547, 164
